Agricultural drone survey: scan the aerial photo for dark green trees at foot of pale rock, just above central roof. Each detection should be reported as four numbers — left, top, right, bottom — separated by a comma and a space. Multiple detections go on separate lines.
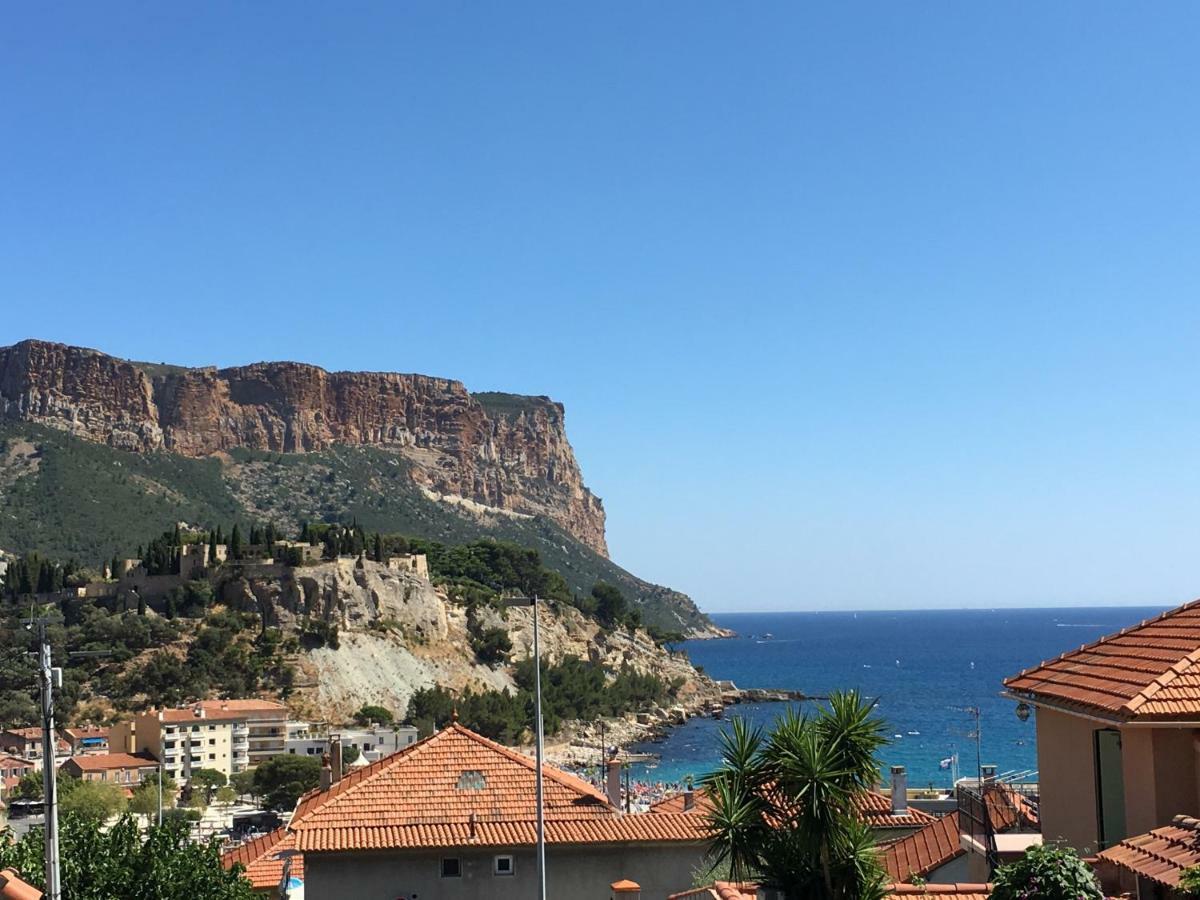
408, 656, 671, 744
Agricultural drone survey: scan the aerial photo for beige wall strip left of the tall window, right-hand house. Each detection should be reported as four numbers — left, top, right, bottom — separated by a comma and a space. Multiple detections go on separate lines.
1037, 707, 1100, 853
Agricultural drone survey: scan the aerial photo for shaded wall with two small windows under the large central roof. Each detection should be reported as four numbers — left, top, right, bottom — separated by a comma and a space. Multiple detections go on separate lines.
304, 844, 704, 900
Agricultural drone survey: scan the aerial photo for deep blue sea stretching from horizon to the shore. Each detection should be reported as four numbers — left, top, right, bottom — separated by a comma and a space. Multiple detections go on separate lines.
632, 607, 1163, 787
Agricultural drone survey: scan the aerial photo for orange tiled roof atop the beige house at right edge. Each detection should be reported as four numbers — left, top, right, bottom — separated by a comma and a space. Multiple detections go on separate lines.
1004, 600, 1200, 720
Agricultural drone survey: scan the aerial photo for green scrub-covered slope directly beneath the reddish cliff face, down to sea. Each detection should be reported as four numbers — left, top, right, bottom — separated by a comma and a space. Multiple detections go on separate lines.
0, 422, 708, 630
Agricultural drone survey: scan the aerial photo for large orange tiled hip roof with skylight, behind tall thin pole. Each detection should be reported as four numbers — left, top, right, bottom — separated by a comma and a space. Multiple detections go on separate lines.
288, 724, 708, 852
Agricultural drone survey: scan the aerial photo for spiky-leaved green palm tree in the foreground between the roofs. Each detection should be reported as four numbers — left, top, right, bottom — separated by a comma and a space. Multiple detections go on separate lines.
704, 691, 886, 900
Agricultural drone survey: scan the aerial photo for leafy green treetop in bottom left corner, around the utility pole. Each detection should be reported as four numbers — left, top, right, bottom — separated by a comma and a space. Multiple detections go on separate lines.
0, 814, 253, 900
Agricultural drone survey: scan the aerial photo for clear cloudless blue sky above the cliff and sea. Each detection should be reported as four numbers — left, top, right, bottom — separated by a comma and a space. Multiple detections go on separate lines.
0, 0, 1200, 611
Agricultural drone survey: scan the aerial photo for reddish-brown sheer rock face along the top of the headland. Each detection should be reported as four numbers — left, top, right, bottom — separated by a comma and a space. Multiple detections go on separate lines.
0, 341, 607, 556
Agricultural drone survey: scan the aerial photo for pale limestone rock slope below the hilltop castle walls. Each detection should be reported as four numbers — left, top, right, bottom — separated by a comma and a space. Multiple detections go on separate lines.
221, 559, 720, 721
